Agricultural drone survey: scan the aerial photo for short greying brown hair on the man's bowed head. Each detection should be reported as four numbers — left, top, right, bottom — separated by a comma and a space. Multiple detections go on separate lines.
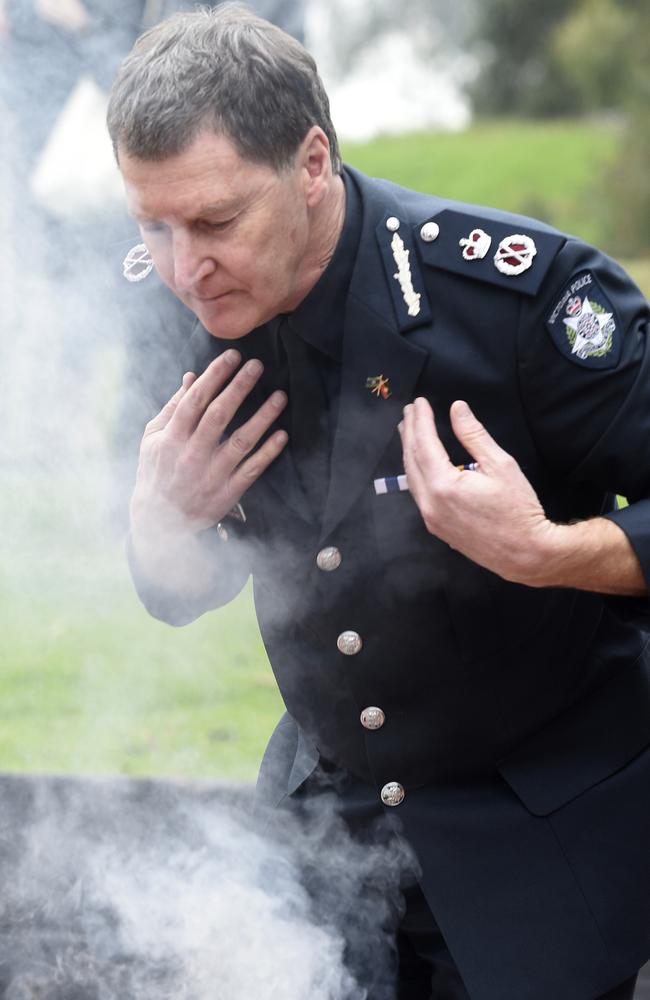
107, 3, 341, 173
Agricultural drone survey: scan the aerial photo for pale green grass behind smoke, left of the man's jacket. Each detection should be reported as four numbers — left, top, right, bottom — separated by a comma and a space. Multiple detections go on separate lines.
0, 568, 282, 781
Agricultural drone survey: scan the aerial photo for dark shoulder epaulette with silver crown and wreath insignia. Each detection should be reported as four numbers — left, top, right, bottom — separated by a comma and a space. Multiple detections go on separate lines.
414, 208, 566, 295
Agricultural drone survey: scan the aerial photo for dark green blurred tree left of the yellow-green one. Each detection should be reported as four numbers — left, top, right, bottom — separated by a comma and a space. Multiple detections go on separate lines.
470, 0, 581, 117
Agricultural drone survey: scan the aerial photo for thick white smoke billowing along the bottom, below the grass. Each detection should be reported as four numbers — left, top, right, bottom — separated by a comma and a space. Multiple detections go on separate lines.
0, 780, 411, 1000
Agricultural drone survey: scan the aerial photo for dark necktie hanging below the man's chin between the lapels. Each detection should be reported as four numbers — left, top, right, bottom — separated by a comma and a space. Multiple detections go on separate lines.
278, 316, 330, 517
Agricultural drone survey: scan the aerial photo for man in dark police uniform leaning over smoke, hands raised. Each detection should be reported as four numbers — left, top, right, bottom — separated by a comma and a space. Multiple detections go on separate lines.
109, 6, 650, 1000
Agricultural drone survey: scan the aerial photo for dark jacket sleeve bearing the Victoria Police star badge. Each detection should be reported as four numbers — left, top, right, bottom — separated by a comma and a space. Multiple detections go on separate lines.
518, 240, 650, 592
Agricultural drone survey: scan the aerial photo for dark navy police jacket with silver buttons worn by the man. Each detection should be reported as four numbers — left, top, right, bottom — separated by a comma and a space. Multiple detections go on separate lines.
129, 171, 650, 1000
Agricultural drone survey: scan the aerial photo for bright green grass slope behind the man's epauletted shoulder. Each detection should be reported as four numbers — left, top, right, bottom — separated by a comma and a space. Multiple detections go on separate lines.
343, 120, 619, 246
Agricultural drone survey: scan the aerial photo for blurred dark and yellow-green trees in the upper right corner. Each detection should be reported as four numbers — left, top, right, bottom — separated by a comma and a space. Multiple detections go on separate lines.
471, 0, 650, 257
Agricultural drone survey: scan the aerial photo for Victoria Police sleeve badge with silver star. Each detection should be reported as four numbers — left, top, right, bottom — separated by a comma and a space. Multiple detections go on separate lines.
546, 271, 623, 368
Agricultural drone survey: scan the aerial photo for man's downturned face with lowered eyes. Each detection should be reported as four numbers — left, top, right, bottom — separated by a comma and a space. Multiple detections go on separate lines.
119, 132, 316, 339
